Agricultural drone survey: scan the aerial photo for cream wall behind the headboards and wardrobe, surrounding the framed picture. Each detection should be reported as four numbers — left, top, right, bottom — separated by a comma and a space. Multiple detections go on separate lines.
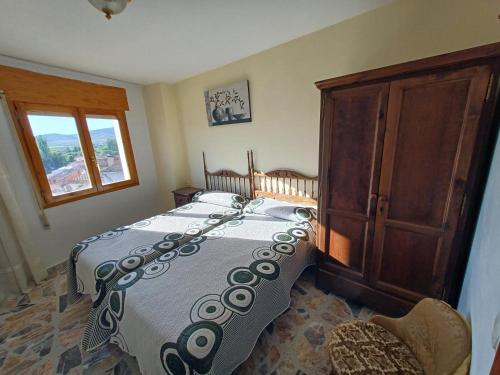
151, 0, 500, 186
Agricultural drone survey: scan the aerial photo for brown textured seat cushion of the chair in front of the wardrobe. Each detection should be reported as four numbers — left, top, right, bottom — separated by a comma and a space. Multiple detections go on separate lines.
328, 320, 424, 375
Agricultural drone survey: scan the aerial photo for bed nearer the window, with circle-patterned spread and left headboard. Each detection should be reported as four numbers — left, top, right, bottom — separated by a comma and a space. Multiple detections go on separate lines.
68, 153, 251, 351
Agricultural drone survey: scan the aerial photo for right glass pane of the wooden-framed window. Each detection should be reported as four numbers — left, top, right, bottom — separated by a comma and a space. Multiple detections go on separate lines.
87, 116, 130, 185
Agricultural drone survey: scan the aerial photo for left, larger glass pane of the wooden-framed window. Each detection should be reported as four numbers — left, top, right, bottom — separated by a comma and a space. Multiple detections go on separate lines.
28, 113, 92, 196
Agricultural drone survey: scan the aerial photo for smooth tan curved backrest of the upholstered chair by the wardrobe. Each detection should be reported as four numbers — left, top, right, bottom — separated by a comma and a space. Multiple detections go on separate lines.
371, 298, 471, 375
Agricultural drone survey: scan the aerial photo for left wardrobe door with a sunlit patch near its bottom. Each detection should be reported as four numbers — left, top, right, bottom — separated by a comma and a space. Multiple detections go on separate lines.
319, 83, 389, 279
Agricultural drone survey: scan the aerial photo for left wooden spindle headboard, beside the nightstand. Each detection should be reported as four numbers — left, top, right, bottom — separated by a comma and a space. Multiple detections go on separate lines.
203, 151, 254, 199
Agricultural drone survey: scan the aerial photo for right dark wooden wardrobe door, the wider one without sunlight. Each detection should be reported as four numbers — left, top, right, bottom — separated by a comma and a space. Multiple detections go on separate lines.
371, 66, 491, 301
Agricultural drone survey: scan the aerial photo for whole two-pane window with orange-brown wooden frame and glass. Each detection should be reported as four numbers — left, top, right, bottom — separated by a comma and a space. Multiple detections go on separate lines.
14, 103, 138, 207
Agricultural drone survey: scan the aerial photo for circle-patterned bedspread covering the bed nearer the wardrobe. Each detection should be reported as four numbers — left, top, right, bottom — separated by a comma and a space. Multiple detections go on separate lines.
101, 213, 315, 375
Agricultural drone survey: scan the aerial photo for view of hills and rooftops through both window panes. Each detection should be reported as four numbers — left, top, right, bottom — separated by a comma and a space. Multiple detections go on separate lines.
28, 114, 130, 196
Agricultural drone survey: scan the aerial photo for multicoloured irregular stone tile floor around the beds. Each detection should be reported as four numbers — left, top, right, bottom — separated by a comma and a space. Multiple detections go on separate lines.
0, 267, 372, 375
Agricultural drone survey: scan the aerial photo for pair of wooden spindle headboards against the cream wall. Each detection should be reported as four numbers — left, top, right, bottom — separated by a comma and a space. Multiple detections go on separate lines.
203, 151, 319, 204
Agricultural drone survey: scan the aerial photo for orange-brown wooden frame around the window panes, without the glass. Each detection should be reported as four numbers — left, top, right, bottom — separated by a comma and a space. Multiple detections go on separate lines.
10, 101, 139, 208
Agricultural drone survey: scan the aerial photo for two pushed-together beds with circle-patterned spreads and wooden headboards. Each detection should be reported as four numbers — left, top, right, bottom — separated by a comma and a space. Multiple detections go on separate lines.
68, 152, 318, 374
